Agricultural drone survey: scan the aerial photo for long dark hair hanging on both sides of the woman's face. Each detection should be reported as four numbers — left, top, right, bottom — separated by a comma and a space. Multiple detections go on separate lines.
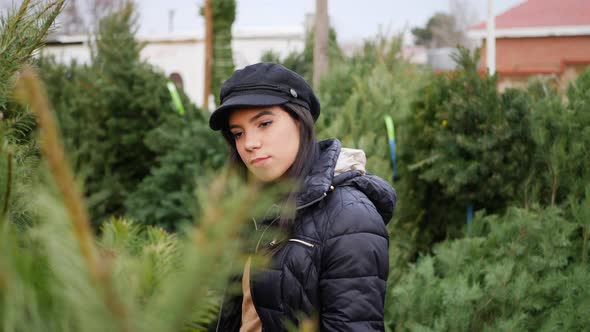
221, 103, 319, 232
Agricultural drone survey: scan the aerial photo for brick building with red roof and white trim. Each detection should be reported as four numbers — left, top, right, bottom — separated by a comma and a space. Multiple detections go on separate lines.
469, 0, 590, 88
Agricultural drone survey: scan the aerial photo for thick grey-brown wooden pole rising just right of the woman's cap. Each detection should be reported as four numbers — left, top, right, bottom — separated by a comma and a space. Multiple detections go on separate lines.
313, 0, 329, 89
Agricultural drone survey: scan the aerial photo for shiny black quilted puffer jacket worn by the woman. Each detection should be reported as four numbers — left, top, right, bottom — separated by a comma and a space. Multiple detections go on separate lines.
217, 139, 396, 332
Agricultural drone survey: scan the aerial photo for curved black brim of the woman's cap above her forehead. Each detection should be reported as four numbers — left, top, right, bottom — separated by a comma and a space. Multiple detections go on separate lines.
209, 94, 288, 130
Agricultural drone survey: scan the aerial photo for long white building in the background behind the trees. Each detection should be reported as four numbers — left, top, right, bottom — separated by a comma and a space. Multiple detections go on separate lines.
42, 26, 305, 105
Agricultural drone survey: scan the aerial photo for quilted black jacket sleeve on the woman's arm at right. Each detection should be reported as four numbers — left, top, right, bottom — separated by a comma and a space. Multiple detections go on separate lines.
319, 193, 389, 331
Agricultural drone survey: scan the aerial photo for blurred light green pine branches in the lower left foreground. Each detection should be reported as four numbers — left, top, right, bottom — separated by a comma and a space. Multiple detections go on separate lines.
0, 171, 278, 332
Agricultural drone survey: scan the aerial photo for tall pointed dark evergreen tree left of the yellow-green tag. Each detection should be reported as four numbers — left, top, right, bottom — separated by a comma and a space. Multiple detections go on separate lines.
83, 5, 163, 217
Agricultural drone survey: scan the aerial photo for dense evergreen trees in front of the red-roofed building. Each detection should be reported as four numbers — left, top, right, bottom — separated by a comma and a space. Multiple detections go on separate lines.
396, 50, 590, 272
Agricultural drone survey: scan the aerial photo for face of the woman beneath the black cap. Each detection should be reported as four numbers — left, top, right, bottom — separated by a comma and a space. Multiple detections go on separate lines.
229, 106, 299, 182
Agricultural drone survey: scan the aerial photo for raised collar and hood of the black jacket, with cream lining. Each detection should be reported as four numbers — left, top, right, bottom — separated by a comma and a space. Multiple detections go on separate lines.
297, 138, 397, 224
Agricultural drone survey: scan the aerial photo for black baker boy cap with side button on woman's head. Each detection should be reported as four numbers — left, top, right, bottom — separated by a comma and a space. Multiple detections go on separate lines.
209, 62, 320, 130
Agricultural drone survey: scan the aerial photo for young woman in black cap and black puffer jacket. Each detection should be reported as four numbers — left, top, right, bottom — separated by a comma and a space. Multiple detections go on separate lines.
209, 63, 396, 331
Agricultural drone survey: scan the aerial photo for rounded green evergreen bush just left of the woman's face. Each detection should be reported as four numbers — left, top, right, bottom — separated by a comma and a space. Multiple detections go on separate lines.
125, 113, 227, 230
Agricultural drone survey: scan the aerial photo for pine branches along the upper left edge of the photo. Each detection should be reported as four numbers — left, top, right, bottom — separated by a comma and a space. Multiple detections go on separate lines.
0, 0, 64, 226
